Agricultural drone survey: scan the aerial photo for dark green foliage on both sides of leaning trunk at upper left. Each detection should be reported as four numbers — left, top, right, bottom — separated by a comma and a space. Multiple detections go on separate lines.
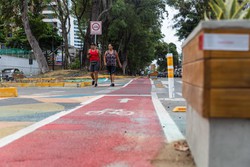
0, 0, 62, 50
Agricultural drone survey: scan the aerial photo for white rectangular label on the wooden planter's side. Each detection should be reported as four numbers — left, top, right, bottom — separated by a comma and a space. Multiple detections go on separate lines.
203, 33, 249, 51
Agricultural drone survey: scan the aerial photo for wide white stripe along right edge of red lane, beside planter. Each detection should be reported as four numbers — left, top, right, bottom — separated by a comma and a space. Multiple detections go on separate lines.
152, 92, 185, 143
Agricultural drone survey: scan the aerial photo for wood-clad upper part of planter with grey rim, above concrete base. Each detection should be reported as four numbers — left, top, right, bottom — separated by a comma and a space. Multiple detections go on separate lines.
183, 20, 250, 118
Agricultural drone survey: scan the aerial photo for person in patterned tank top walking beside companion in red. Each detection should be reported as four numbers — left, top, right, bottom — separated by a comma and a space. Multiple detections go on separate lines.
103, 44, 122, 86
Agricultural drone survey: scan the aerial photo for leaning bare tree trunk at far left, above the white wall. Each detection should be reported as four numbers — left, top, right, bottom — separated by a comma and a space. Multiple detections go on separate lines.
21, 0, 49, 73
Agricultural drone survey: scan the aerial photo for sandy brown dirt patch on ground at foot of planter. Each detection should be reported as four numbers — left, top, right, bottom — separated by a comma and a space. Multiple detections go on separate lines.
152, 141, 196, 167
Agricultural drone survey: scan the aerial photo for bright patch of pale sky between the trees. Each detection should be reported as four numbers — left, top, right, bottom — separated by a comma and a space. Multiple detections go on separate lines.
161, 6, 182, 53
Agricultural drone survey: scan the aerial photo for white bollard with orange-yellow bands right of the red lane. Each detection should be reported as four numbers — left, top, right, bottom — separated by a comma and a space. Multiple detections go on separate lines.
166, 53, 175, 99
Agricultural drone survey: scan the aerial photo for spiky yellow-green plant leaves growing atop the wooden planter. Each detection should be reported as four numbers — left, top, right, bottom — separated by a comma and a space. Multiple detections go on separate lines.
205, 0, 250, 20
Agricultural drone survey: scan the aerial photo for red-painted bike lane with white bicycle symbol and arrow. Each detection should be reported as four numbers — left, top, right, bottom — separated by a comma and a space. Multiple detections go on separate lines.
0, 79, 165, 167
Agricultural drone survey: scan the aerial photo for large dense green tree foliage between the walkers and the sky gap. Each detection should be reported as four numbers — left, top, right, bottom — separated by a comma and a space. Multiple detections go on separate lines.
102, 0, 166, 73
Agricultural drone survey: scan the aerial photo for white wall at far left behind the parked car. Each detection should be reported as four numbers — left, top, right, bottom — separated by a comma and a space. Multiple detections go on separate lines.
0, 55, 41, 76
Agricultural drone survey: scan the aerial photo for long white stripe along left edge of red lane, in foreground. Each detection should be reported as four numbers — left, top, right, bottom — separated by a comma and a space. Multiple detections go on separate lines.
0, 95, 104, 148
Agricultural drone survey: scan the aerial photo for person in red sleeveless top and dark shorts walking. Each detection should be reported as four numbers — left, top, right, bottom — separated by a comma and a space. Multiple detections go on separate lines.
87, 43, 100, 87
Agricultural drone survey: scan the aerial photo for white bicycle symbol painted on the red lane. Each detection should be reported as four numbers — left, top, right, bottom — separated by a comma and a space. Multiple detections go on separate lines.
86, 108, 134, 116
